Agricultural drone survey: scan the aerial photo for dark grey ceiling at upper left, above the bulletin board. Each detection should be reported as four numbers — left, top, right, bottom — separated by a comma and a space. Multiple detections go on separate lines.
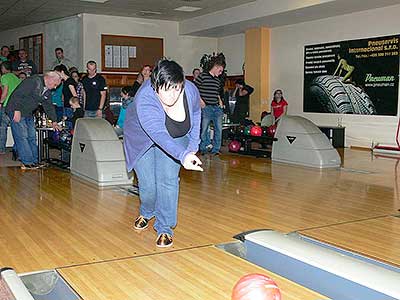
0, 0, 254, 31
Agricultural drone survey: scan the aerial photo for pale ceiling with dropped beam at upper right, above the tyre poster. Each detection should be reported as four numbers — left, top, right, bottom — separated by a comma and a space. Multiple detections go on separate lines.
179, 0, 400, 37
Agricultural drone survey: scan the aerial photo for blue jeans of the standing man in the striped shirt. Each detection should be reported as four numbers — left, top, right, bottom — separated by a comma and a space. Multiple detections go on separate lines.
200, 105, 224, 153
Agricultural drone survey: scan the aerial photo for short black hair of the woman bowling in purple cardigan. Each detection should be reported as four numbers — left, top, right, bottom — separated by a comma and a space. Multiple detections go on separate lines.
151, 59, 185, 92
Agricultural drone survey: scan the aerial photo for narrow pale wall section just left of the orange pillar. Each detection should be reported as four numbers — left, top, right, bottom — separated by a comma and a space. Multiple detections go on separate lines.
218, 33, 245, 75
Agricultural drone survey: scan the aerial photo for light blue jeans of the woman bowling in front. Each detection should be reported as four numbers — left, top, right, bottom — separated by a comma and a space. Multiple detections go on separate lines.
135, 136, 189, 236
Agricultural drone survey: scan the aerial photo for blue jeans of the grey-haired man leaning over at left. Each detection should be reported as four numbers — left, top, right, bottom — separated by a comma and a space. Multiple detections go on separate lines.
9, 113, 38, 165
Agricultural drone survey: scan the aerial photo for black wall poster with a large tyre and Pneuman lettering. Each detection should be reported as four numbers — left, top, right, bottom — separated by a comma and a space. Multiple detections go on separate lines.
303, 35, 400, 116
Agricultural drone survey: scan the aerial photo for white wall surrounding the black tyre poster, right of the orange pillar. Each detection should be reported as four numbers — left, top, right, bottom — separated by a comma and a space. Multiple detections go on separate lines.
270, 5, 400, 146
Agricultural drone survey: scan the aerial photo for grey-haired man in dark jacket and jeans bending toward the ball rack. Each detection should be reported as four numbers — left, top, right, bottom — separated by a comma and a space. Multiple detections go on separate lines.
6, 72, 61, 169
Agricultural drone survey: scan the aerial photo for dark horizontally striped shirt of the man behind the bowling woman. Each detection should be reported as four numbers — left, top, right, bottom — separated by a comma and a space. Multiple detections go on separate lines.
194, 72, 221, 105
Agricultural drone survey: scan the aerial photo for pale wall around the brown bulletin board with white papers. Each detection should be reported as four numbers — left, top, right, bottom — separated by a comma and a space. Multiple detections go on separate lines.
82, 14, 217, 74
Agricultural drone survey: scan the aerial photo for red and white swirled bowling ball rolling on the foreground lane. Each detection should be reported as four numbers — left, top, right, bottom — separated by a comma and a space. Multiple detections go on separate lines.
232, 274, 281, 300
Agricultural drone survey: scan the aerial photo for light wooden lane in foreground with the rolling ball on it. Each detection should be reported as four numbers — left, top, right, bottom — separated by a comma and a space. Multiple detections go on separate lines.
58, 246, 328, 300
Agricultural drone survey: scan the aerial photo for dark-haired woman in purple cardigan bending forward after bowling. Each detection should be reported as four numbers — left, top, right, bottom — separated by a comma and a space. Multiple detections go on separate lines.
124, 59, 203, 247
